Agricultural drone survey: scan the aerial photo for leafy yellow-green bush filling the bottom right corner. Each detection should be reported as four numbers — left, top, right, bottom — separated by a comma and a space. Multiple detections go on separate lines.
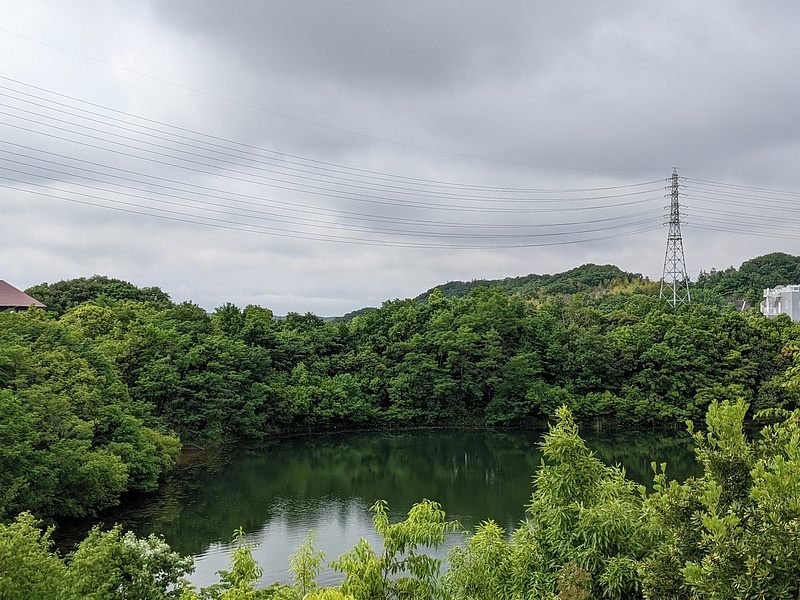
641, 399, 800, 599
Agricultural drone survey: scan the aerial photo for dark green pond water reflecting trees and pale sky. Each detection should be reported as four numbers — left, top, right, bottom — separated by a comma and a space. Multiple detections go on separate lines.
61, 429, 699, 585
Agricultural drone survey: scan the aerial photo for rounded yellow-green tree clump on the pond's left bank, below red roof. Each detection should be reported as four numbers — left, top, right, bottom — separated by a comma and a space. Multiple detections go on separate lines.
0, 307, 179, 518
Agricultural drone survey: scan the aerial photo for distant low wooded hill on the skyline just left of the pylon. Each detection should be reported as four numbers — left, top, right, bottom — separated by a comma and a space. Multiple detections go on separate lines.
415, 263, 649, 301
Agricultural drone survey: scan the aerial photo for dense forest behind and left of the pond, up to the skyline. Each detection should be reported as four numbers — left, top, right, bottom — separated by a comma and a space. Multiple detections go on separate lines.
0, 255, 800, 517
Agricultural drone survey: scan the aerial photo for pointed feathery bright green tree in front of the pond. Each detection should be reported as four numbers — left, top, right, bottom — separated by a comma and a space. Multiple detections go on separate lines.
526, 408, 654, 598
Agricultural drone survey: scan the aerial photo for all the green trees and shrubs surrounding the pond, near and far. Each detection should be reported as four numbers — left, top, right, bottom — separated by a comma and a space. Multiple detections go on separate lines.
0, 254, 800, 600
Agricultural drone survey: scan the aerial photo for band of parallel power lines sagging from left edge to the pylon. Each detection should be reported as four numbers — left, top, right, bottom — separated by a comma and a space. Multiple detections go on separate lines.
0, 77, 661, 248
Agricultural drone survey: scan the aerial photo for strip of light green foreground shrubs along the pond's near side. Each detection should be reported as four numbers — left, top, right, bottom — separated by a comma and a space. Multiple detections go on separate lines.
0, 398, 800, 600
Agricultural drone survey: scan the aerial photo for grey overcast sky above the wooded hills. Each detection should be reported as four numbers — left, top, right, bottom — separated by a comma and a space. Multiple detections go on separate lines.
0, 0, 800, 316
